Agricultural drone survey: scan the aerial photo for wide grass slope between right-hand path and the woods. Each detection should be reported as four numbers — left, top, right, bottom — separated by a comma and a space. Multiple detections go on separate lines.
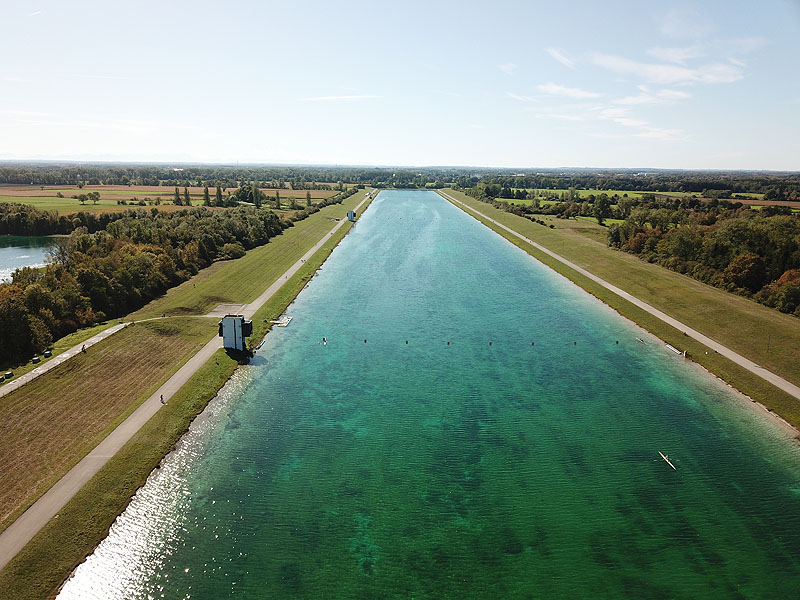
440, 190, 800, 396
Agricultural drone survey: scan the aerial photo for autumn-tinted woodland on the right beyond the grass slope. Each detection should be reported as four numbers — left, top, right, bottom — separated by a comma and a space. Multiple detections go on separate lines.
467, 182, 800, 316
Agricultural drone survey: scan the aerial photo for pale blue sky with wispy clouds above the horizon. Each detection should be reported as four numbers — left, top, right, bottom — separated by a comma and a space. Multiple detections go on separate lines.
0, 0, 800, 171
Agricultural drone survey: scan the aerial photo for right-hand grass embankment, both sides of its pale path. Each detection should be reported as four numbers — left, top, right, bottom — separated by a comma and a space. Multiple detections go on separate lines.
440, 190, 800, 427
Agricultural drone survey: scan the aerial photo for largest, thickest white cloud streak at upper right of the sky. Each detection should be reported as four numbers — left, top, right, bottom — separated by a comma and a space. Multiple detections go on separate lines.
592, 54, 744, 85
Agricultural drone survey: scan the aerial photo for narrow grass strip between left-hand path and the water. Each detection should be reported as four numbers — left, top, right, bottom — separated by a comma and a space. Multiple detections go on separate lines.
0, 196, 366, 600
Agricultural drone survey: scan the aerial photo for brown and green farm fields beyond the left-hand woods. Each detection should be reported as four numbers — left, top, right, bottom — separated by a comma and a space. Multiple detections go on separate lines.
0, 184, 337, 214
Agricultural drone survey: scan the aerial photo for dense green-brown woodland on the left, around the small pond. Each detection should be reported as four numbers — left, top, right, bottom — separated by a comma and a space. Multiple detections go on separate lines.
0, 189, 355, 362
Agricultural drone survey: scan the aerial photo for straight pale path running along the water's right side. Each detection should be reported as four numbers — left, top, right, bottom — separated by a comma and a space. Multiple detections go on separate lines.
440, 190, 800, 399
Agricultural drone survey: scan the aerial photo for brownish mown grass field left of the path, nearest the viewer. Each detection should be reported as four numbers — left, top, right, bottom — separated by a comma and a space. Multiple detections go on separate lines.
0, 318, 216, 530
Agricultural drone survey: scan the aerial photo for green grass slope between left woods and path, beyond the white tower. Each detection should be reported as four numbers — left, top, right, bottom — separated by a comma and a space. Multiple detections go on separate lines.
130, 190, 367, 319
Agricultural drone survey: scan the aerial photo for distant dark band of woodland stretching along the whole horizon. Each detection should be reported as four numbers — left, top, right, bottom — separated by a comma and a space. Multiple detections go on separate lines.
0, 162, 800, 200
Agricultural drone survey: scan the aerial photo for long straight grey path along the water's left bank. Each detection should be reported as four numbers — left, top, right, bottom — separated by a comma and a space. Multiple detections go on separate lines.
0, 193, 369, 569
